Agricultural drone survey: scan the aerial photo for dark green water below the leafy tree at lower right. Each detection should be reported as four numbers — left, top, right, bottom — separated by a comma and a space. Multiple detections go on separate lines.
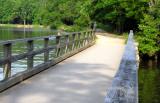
139, 60, 160, 103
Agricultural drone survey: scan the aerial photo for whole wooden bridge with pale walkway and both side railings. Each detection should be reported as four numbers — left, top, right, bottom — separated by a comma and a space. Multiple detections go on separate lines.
0, 30, 137, 103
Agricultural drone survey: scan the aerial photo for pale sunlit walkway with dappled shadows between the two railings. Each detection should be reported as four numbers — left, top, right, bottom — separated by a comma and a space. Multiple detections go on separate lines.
0, 35, 124, 103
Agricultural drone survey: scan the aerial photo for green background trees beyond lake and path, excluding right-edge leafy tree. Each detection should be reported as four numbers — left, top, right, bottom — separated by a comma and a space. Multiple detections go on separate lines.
0, 0, 148, 33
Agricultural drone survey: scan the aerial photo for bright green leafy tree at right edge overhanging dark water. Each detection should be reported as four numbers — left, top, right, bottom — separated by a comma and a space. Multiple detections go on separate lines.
138, 2, 160, 57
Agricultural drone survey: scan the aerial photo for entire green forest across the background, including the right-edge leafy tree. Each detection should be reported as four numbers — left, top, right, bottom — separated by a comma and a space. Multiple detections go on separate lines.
0, 0, 160, 57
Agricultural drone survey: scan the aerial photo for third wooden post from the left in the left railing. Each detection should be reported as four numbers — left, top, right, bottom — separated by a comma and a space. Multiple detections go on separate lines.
44, 38, 49, 62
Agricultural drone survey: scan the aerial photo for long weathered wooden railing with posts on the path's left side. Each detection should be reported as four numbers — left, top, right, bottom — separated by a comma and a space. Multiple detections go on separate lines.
0, 30, 95, 91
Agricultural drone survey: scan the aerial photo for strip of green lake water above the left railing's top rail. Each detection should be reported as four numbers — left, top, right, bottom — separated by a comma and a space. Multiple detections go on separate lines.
0, 27, 56, 41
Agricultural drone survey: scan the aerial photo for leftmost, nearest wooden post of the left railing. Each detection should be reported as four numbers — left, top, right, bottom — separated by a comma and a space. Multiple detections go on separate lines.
3, 43, 12, 79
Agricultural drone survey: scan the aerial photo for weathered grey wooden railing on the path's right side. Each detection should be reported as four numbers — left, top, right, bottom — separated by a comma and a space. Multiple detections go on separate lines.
105, 30, 139, 103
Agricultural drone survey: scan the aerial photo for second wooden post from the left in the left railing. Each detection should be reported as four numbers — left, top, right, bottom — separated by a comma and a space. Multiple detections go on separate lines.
27, 40, 34, 69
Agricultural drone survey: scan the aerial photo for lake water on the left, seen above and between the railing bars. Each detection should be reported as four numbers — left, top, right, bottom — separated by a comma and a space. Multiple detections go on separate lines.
0, 27, 56, 80
